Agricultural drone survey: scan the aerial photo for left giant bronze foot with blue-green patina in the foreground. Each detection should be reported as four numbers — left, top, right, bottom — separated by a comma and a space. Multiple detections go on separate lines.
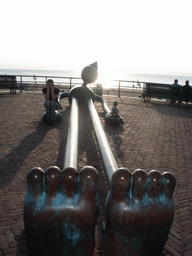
24, 166, 99, 256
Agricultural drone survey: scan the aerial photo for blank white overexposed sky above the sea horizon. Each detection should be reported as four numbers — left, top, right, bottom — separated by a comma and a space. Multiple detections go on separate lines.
0, 0, 192, 77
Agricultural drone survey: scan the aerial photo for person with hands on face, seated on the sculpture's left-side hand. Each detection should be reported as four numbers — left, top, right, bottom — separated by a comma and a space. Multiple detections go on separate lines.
42, 79, 61, 124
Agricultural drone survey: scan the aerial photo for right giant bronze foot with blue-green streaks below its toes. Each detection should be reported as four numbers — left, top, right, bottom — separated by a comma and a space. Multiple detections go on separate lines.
104, 168, 175, 256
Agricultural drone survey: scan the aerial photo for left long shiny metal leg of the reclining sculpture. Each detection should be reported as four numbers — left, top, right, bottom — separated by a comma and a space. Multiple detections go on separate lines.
64, 97, 79, 170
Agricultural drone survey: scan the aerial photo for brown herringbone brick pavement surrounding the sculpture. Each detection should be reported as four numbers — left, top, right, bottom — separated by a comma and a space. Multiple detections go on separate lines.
0, 92, 192, 256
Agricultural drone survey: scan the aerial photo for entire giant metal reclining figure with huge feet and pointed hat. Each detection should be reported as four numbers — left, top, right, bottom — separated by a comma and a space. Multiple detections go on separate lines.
24, 63, 175, 256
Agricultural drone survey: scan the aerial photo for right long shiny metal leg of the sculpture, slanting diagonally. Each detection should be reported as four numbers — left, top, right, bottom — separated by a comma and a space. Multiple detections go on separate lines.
88, 99, 118, 187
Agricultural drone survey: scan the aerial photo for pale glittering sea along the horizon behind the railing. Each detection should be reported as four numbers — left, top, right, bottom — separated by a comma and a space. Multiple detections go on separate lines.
0, 69, 192, 88
